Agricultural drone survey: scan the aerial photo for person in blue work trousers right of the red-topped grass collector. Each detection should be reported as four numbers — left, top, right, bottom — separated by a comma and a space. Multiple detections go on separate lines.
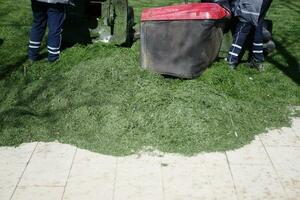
227, 0, 272, 71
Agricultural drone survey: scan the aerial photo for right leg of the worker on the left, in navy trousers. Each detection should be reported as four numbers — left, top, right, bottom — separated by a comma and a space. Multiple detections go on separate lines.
47, 4, 66, 62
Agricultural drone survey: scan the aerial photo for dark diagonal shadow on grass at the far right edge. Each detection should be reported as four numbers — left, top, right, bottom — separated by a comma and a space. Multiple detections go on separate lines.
267, 39, 300, 85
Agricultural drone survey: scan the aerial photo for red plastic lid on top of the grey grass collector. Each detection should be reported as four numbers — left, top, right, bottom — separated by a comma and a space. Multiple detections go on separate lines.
141, 3, 230, 22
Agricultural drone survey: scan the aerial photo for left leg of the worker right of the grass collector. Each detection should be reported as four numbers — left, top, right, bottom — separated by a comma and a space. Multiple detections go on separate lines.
227, 21, 253, 65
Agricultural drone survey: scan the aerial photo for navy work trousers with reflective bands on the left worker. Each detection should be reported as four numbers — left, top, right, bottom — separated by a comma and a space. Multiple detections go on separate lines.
28, 0, 66, 62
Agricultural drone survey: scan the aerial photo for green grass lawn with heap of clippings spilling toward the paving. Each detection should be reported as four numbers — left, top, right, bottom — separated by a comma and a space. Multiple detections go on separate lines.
0, 0, 300, 155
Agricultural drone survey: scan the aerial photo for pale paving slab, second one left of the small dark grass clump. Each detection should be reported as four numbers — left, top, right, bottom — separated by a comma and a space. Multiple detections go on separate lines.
63, 155, 117, 200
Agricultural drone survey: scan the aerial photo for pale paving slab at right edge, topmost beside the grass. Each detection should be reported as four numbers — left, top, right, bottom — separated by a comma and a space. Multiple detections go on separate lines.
259, 128, 300, 147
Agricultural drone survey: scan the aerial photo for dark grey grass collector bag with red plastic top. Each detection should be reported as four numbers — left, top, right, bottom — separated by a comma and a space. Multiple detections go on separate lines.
141, 3, 230, 78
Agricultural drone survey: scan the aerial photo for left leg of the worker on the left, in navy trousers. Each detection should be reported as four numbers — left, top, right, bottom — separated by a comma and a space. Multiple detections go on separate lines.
28, 1, 47, 61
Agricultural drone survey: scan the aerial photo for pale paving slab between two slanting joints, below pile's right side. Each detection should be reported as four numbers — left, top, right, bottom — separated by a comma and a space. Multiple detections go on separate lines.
226, 137, 271, 165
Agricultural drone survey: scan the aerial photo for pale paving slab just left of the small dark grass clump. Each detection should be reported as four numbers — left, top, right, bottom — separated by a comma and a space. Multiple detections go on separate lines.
114, 155, 163, 200
